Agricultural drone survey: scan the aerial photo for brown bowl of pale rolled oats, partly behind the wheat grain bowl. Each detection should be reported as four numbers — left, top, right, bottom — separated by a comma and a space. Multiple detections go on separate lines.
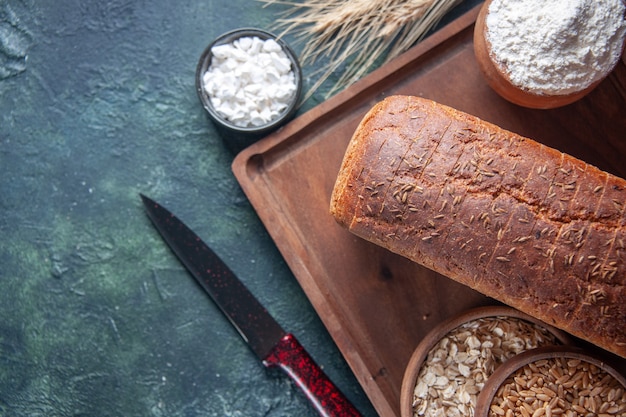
400, 306, 571, 417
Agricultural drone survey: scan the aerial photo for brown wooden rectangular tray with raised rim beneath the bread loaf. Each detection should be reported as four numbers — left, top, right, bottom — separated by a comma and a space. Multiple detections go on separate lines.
232, 6, 626, 416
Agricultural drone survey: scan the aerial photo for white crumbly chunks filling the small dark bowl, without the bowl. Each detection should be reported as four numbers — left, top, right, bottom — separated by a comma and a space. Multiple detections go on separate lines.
202, 36, 297, 127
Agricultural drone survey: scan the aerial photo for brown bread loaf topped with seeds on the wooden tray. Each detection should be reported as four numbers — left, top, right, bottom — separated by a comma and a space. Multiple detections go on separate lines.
330, 96, 626, 357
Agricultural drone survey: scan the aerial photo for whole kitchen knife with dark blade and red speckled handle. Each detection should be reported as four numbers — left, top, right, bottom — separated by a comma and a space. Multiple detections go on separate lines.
140, 194, 360, 417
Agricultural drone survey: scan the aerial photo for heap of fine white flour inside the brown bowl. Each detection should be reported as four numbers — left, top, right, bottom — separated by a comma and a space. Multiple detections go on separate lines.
486, 0, 626, 95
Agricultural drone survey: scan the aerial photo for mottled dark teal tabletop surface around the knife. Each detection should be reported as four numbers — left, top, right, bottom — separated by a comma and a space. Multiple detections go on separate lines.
0, 0, 478, 417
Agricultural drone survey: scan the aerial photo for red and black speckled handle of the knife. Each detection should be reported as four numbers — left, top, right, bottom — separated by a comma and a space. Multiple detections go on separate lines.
263, 334, 361, 417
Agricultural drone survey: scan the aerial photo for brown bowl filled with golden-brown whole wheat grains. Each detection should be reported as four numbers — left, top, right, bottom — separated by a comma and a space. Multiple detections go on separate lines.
476, 346, 626, 417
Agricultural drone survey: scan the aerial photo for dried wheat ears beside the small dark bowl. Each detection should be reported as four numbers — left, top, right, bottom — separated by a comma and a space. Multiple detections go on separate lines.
260, 0, 462, 100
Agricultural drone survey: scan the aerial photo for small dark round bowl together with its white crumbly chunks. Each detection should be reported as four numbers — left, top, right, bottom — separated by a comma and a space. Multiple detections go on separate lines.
196, 28, 302, 136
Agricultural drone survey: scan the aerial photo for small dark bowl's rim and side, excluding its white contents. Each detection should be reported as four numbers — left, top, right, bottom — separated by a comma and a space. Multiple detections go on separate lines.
196, 28, 302, 138
